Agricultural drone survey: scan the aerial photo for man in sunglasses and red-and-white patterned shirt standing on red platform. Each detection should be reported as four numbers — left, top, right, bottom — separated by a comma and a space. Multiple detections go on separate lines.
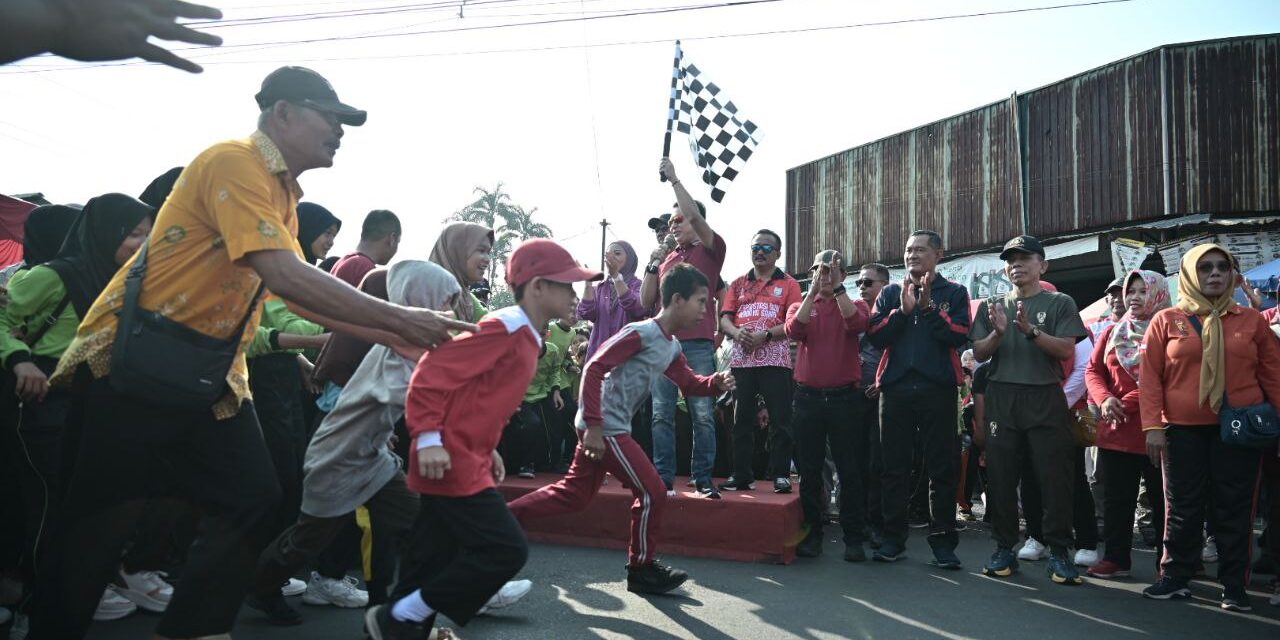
721, 229, 801, 493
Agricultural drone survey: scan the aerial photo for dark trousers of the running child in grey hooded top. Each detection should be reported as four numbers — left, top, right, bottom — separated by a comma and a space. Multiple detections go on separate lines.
253, 474, 419, 598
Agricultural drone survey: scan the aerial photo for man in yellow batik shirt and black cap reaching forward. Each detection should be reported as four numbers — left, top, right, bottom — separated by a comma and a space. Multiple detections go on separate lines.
31, 67, 471, 640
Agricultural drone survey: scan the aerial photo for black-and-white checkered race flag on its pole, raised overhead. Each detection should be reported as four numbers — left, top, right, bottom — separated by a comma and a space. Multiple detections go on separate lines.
662, 41, 760, 202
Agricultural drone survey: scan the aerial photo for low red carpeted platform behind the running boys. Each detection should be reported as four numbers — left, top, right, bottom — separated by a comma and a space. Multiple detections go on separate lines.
498, 474, 801, 564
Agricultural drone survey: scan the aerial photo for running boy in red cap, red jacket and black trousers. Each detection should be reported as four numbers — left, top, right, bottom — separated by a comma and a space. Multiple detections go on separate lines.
365, 239, 602, 640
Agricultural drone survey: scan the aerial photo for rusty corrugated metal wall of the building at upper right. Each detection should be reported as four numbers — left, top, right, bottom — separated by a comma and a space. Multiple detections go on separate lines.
786, 35, 1280, 271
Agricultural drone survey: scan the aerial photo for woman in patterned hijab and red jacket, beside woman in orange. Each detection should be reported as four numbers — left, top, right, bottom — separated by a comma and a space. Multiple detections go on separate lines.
1084, 270, 1170, 579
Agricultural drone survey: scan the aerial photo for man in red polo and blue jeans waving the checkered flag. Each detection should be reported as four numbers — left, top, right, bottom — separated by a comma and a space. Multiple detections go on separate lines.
640, 157, 724, 498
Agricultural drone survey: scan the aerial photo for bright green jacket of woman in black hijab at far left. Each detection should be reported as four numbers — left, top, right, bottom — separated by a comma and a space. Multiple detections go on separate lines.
0, 265, 79, 370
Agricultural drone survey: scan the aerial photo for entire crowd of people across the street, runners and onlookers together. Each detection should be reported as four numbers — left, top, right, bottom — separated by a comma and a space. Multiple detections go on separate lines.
0, 58, 1280, 640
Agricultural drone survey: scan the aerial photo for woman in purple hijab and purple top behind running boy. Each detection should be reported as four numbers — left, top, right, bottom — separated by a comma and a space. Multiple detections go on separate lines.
577, 241, 649, 362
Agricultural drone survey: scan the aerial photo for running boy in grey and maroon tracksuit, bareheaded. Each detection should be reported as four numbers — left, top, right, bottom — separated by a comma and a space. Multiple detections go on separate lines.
509, 265, 733, 594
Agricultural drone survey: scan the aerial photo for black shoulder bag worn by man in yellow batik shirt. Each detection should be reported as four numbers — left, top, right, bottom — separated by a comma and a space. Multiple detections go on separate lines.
110, 242, 264, 410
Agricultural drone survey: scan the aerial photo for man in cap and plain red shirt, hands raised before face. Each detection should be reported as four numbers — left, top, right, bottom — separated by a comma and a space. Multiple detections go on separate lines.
786, 250, 870, 562
